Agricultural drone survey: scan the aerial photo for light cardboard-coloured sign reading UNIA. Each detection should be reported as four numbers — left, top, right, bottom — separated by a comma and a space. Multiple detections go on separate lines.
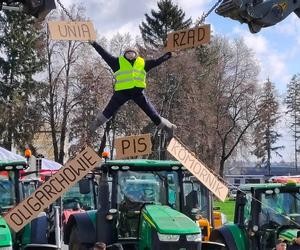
48, 21, 96, 41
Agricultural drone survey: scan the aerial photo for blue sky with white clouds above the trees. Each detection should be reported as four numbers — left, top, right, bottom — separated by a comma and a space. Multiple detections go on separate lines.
61, 0, 300, 161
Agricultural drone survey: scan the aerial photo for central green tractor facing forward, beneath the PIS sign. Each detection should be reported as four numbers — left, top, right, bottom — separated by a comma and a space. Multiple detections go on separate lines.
64, 160, 223, 250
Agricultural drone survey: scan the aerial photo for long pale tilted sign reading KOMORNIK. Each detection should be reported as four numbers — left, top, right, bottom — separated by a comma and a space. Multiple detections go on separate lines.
167, 138, 229, 201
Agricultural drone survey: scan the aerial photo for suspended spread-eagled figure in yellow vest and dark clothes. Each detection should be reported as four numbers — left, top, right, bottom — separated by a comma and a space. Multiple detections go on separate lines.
89, 42, 176, 138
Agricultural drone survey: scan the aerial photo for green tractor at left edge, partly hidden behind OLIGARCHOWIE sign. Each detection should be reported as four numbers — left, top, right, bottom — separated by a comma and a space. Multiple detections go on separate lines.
0, 161, 60, 250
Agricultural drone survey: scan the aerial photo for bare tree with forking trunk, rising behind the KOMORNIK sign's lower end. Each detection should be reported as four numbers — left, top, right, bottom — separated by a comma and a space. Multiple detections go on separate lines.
199, 38, 259, 176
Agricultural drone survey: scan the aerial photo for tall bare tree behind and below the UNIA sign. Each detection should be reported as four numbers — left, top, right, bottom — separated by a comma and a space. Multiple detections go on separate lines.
43, 6, 91, 163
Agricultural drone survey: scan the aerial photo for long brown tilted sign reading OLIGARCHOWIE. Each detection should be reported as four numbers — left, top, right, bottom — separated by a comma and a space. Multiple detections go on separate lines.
4, 147, 101, 232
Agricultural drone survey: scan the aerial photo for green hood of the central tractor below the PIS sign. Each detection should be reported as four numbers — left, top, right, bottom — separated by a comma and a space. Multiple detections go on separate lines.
142, 205, 200, 234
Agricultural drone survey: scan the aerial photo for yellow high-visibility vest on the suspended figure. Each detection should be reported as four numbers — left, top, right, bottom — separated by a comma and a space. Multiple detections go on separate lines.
114, 56, 146, 91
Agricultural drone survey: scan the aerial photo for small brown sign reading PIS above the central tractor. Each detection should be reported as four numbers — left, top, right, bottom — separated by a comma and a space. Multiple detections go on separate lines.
115, 134, 152, 159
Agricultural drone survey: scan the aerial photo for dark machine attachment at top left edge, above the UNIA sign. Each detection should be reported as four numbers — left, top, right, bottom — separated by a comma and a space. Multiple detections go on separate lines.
22, 0, 56, 20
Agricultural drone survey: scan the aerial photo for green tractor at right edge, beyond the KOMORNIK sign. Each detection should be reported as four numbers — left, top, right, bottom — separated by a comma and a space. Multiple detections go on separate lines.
210, 183, 300, 250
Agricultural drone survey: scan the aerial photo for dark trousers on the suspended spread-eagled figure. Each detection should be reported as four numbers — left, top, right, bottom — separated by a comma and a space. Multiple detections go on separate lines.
103, 88, 161, 126
